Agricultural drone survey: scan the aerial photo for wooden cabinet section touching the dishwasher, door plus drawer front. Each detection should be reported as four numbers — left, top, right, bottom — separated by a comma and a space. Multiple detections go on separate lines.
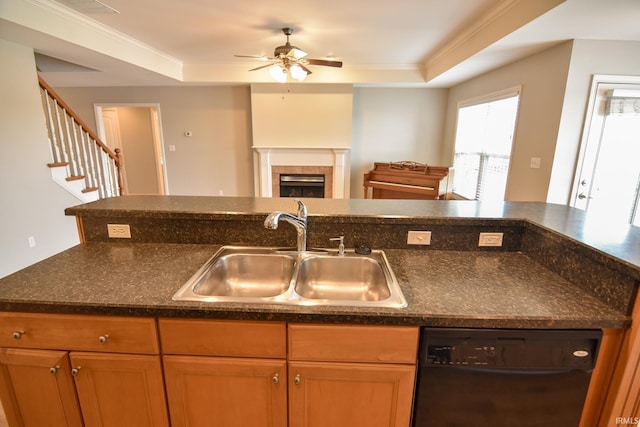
289, 324, 419, 427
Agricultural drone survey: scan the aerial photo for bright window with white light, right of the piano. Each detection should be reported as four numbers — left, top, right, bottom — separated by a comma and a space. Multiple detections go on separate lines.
453, 88, 520, 201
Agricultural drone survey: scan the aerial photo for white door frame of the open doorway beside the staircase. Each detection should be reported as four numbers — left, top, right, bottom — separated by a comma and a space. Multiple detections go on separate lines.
93, 102, 169, 195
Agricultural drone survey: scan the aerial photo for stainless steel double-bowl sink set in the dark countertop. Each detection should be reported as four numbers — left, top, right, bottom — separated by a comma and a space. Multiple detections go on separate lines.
173, 246, 407, 308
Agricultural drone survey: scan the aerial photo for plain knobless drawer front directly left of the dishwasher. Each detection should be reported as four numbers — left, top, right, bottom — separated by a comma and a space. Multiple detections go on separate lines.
289, 324, 419, 363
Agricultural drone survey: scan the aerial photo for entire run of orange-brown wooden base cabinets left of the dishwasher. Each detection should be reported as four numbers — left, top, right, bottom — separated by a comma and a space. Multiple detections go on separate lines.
0, 313, 418, 427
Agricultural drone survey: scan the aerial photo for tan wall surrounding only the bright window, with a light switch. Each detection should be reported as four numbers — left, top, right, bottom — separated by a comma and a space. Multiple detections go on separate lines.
442, 42, 572, 201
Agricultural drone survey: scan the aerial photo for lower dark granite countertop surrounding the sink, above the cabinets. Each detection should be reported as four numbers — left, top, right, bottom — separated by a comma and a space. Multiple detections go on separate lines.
0, 243, 628, 329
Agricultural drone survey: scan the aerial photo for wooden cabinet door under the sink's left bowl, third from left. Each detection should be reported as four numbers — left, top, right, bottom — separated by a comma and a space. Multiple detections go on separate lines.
164, 356, 287, 427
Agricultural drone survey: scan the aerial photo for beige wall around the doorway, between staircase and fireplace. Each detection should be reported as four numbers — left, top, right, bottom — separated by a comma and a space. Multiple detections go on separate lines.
54, 86, 253, 196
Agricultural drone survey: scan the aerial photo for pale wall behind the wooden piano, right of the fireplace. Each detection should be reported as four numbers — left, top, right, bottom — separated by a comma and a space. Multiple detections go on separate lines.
351, 87, 450, 198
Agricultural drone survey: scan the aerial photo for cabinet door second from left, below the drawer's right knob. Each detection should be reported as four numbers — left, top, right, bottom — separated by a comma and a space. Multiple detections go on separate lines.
70, 352, 169, 427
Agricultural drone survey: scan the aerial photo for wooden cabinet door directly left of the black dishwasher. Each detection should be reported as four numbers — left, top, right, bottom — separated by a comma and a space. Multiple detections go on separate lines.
289, 362, 415, 427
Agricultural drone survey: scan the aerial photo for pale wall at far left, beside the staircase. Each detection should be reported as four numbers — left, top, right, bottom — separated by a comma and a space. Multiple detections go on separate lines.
0, 39, 80, 277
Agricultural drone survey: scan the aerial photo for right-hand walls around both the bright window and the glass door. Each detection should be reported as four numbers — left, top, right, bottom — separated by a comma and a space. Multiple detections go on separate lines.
442, 40, 640, 204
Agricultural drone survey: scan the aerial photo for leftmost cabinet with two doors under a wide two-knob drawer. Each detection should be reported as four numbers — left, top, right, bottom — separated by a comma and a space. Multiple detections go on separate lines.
0, 313, 169, 426
